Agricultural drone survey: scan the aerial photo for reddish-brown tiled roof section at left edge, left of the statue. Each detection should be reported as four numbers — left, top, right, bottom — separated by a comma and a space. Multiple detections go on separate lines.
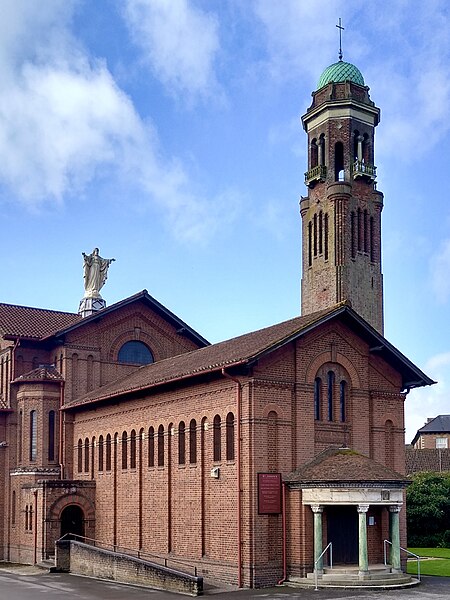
0, 303, 81, 339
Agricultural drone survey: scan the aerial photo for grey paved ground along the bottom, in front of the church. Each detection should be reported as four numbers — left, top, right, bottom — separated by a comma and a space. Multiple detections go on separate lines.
0, 567, 450, 600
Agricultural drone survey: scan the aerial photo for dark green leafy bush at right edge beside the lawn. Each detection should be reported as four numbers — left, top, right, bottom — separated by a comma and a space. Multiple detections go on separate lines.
406, 472, 450, 548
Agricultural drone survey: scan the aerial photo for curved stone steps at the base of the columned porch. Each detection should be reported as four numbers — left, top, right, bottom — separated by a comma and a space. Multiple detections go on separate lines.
286, 565, 419, 589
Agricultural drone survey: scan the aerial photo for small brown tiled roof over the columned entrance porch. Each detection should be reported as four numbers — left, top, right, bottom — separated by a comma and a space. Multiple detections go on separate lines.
284, 448, 406, 484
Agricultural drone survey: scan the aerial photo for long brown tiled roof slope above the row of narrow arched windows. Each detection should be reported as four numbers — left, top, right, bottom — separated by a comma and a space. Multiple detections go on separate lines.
66, 305, 341, 407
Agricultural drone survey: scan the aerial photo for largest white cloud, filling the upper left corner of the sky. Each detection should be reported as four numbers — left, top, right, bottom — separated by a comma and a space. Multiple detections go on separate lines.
0, 0, 233, 241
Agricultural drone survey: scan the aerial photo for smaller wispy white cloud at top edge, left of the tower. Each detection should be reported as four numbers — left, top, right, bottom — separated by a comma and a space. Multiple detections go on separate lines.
125, 0, 219, 99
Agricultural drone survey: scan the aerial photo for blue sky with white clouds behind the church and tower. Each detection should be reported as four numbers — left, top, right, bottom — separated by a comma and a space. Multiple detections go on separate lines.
0, 0, 450, 441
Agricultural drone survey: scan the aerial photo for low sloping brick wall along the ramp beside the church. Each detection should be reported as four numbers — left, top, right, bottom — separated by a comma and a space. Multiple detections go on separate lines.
56, 540, 203, 596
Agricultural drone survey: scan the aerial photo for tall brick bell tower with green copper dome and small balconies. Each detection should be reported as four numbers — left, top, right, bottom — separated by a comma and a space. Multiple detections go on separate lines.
300, 60, 383, 334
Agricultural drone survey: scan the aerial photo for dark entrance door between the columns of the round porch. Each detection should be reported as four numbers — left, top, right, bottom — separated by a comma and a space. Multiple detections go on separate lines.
326, 506, 358, 565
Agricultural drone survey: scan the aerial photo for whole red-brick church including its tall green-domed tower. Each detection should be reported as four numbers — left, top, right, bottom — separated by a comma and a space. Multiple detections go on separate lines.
0, 60, 433, 587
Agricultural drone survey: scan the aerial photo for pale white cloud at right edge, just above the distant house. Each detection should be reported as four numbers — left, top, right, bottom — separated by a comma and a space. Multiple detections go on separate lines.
405, 352, 450, 443
